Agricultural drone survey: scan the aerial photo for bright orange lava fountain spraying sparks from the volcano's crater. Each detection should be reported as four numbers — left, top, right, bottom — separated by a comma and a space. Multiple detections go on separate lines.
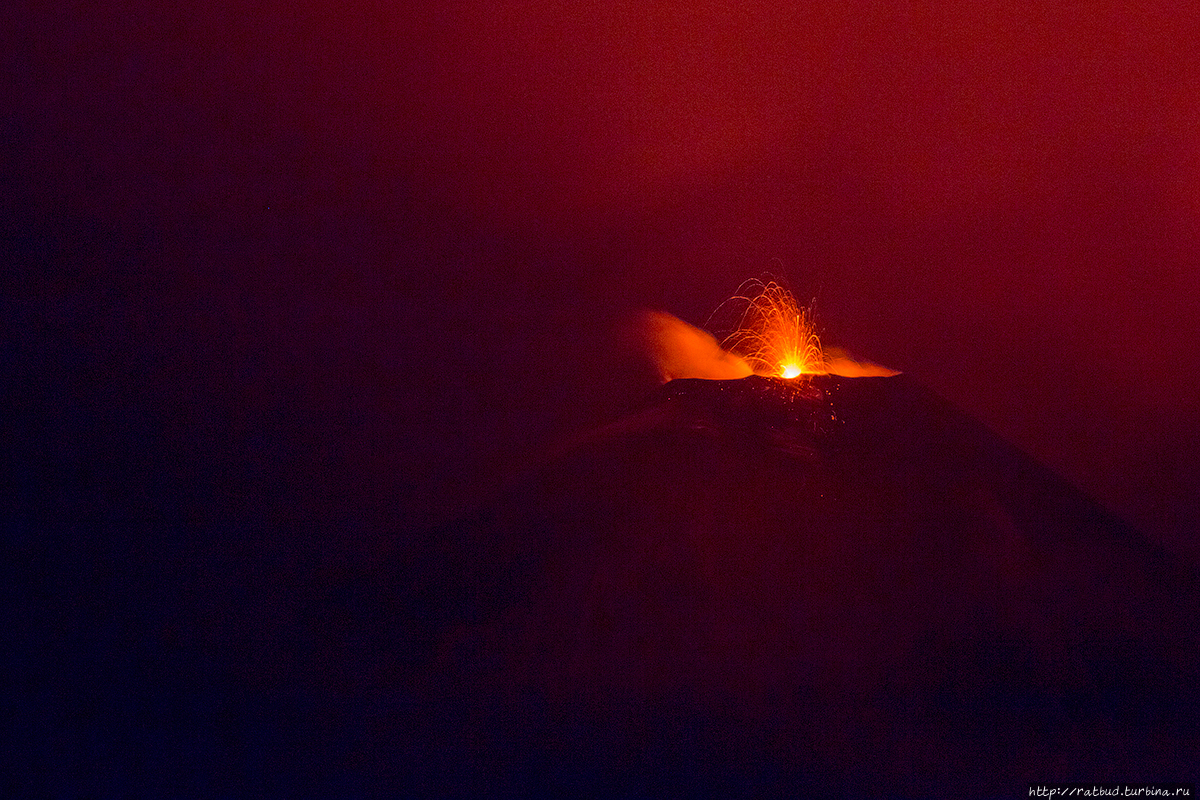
718, 281, 827, 378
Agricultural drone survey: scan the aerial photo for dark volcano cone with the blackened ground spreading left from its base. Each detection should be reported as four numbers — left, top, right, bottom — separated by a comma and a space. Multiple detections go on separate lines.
10, 375, 1200, 798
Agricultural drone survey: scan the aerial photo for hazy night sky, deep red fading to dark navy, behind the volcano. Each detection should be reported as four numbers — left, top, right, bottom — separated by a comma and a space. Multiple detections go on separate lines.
7, 0, 1200, 791
